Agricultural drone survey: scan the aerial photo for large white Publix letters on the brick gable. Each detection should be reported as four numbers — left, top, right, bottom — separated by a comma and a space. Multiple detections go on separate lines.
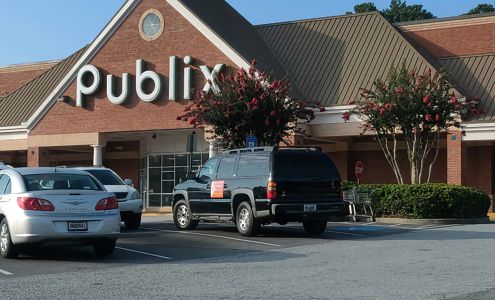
76, 56, 225, 107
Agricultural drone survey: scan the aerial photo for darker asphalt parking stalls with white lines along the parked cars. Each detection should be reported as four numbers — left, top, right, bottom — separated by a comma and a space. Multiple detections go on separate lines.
0, 216, 464, 280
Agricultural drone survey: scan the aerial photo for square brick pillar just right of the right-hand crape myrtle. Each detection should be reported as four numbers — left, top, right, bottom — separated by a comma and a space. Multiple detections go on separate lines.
447, 130, 467, 185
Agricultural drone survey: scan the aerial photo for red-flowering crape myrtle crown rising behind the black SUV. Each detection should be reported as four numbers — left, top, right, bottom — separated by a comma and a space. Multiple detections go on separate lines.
177, 61, 314, 148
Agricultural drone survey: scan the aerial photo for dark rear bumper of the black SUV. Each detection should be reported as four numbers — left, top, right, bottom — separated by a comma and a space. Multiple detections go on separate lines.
269, 202, 345, 222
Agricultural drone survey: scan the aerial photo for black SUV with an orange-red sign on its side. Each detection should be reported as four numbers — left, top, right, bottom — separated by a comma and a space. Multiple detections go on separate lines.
172, 147, 345, 236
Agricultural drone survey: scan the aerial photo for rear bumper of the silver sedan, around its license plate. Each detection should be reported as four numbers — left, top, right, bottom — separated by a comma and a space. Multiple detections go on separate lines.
8, 210, 120, 244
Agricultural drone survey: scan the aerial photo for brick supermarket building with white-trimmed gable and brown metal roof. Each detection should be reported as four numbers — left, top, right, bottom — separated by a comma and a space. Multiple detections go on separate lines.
0, 0, 495, 210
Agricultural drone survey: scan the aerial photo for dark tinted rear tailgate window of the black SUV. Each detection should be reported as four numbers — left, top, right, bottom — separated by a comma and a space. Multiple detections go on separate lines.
273, 151, 340, 180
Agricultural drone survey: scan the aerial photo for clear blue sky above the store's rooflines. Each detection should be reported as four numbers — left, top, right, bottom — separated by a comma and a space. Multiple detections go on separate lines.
0, 0, 495, 66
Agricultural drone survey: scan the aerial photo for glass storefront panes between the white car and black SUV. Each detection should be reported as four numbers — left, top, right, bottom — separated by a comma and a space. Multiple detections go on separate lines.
142, 153, 208, 207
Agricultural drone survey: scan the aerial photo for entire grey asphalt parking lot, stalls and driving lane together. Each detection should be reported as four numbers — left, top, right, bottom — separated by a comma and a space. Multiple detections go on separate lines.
0, 217, 495, 300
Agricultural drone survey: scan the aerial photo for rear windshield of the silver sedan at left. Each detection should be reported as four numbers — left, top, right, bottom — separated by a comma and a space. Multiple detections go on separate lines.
22, 173, 103, 191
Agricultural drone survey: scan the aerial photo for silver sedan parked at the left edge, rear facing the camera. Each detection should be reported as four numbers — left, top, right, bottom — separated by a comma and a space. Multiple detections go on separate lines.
0, 166, 120, 258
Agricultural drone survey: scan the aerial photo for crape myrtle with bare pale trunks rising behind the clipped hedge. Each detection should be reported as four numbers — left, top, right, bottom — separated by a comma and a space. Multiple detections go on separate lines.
343, 65, 481, 184
